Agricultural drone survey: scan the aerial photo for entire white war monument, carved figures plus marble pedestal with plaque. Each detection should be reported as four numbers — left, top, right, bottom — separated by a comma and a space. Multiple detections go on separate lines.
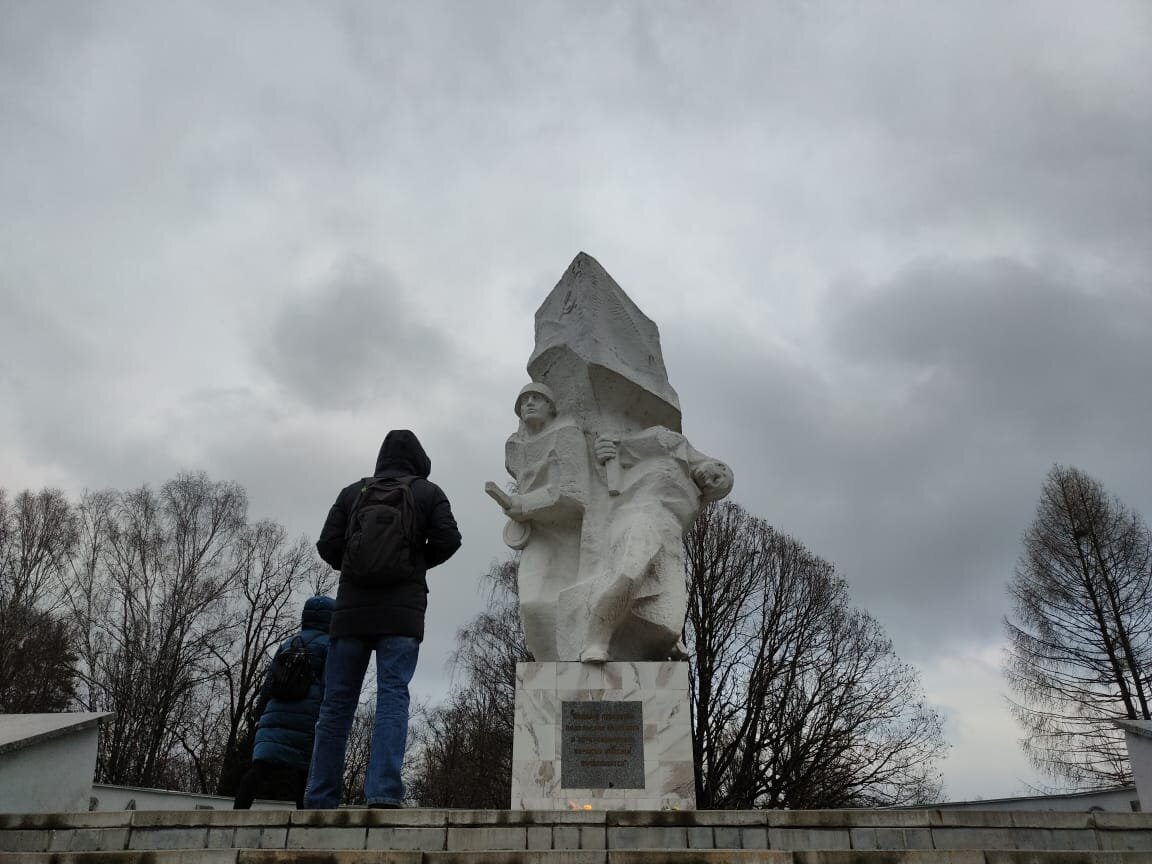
486, 252, 733, 810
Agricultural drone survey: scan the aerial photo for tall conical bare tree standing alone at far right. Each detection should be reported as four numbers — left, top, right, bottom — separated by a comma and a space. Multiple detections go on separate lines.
1005, 465, 1152, 788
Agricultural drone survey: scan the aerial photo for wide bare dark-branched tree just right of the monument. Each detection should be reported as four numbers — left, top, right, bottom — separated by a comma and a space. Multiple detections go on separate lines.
684, 502, 945, 809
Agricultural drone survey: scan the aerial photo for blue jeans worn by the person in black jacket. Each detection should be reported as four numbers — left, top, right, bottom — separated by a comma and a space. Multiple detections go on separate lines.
304, 636, 420, 810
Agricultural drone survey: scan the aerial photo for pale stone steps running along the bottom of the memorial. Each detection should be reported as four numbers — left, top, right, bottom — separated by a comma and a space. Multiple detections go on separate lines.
0, 809, 1152, 864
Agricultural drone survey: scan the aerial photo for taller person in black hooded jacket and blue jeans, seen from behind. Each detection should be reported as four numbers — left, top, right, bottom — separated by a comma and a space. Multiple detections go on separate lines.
304, 430, 460, 810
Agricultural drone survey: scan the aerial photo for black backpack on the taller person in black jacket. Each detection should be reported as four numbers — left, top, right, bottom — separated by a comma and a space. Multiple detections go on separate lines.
340, 477, 416, 588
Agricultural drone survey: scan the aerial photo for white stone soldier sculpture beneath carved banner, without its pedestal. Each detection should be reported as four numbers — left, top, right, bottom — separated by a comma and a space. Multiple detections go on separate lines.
487, 252, 733, 664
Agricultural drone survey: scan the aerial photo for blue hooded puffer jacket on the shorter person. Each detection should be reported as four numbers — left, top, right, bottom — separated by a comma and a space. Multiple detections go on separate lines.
252, 597, 336, 771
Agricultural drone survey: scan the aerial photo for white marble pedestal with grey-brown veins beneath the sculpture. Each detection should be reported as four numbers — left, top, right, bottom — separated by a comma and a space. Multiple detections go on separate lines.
511, 661, 696, 810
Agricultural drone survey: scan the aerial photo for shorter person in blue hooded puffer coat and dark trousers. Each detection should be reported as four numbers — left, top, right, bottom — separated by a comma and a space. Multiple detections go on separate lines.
233, 596, 336, 810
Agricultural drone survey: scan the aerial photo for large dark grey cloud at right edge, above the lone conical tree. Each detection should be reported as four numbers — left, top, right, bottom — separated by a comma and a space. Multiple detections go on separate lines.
828, 259, 1152, 447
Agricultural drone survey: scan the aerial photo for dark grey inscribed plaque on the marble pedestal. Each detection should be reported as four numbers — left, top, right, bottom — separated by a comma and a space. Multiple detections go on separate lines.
560, 702, 644, 789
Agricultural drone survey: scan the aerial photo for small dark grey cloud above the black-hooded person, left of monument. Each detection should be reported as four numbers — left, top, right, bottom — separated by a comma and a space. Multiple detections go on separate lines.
259, 262, 456, 409
